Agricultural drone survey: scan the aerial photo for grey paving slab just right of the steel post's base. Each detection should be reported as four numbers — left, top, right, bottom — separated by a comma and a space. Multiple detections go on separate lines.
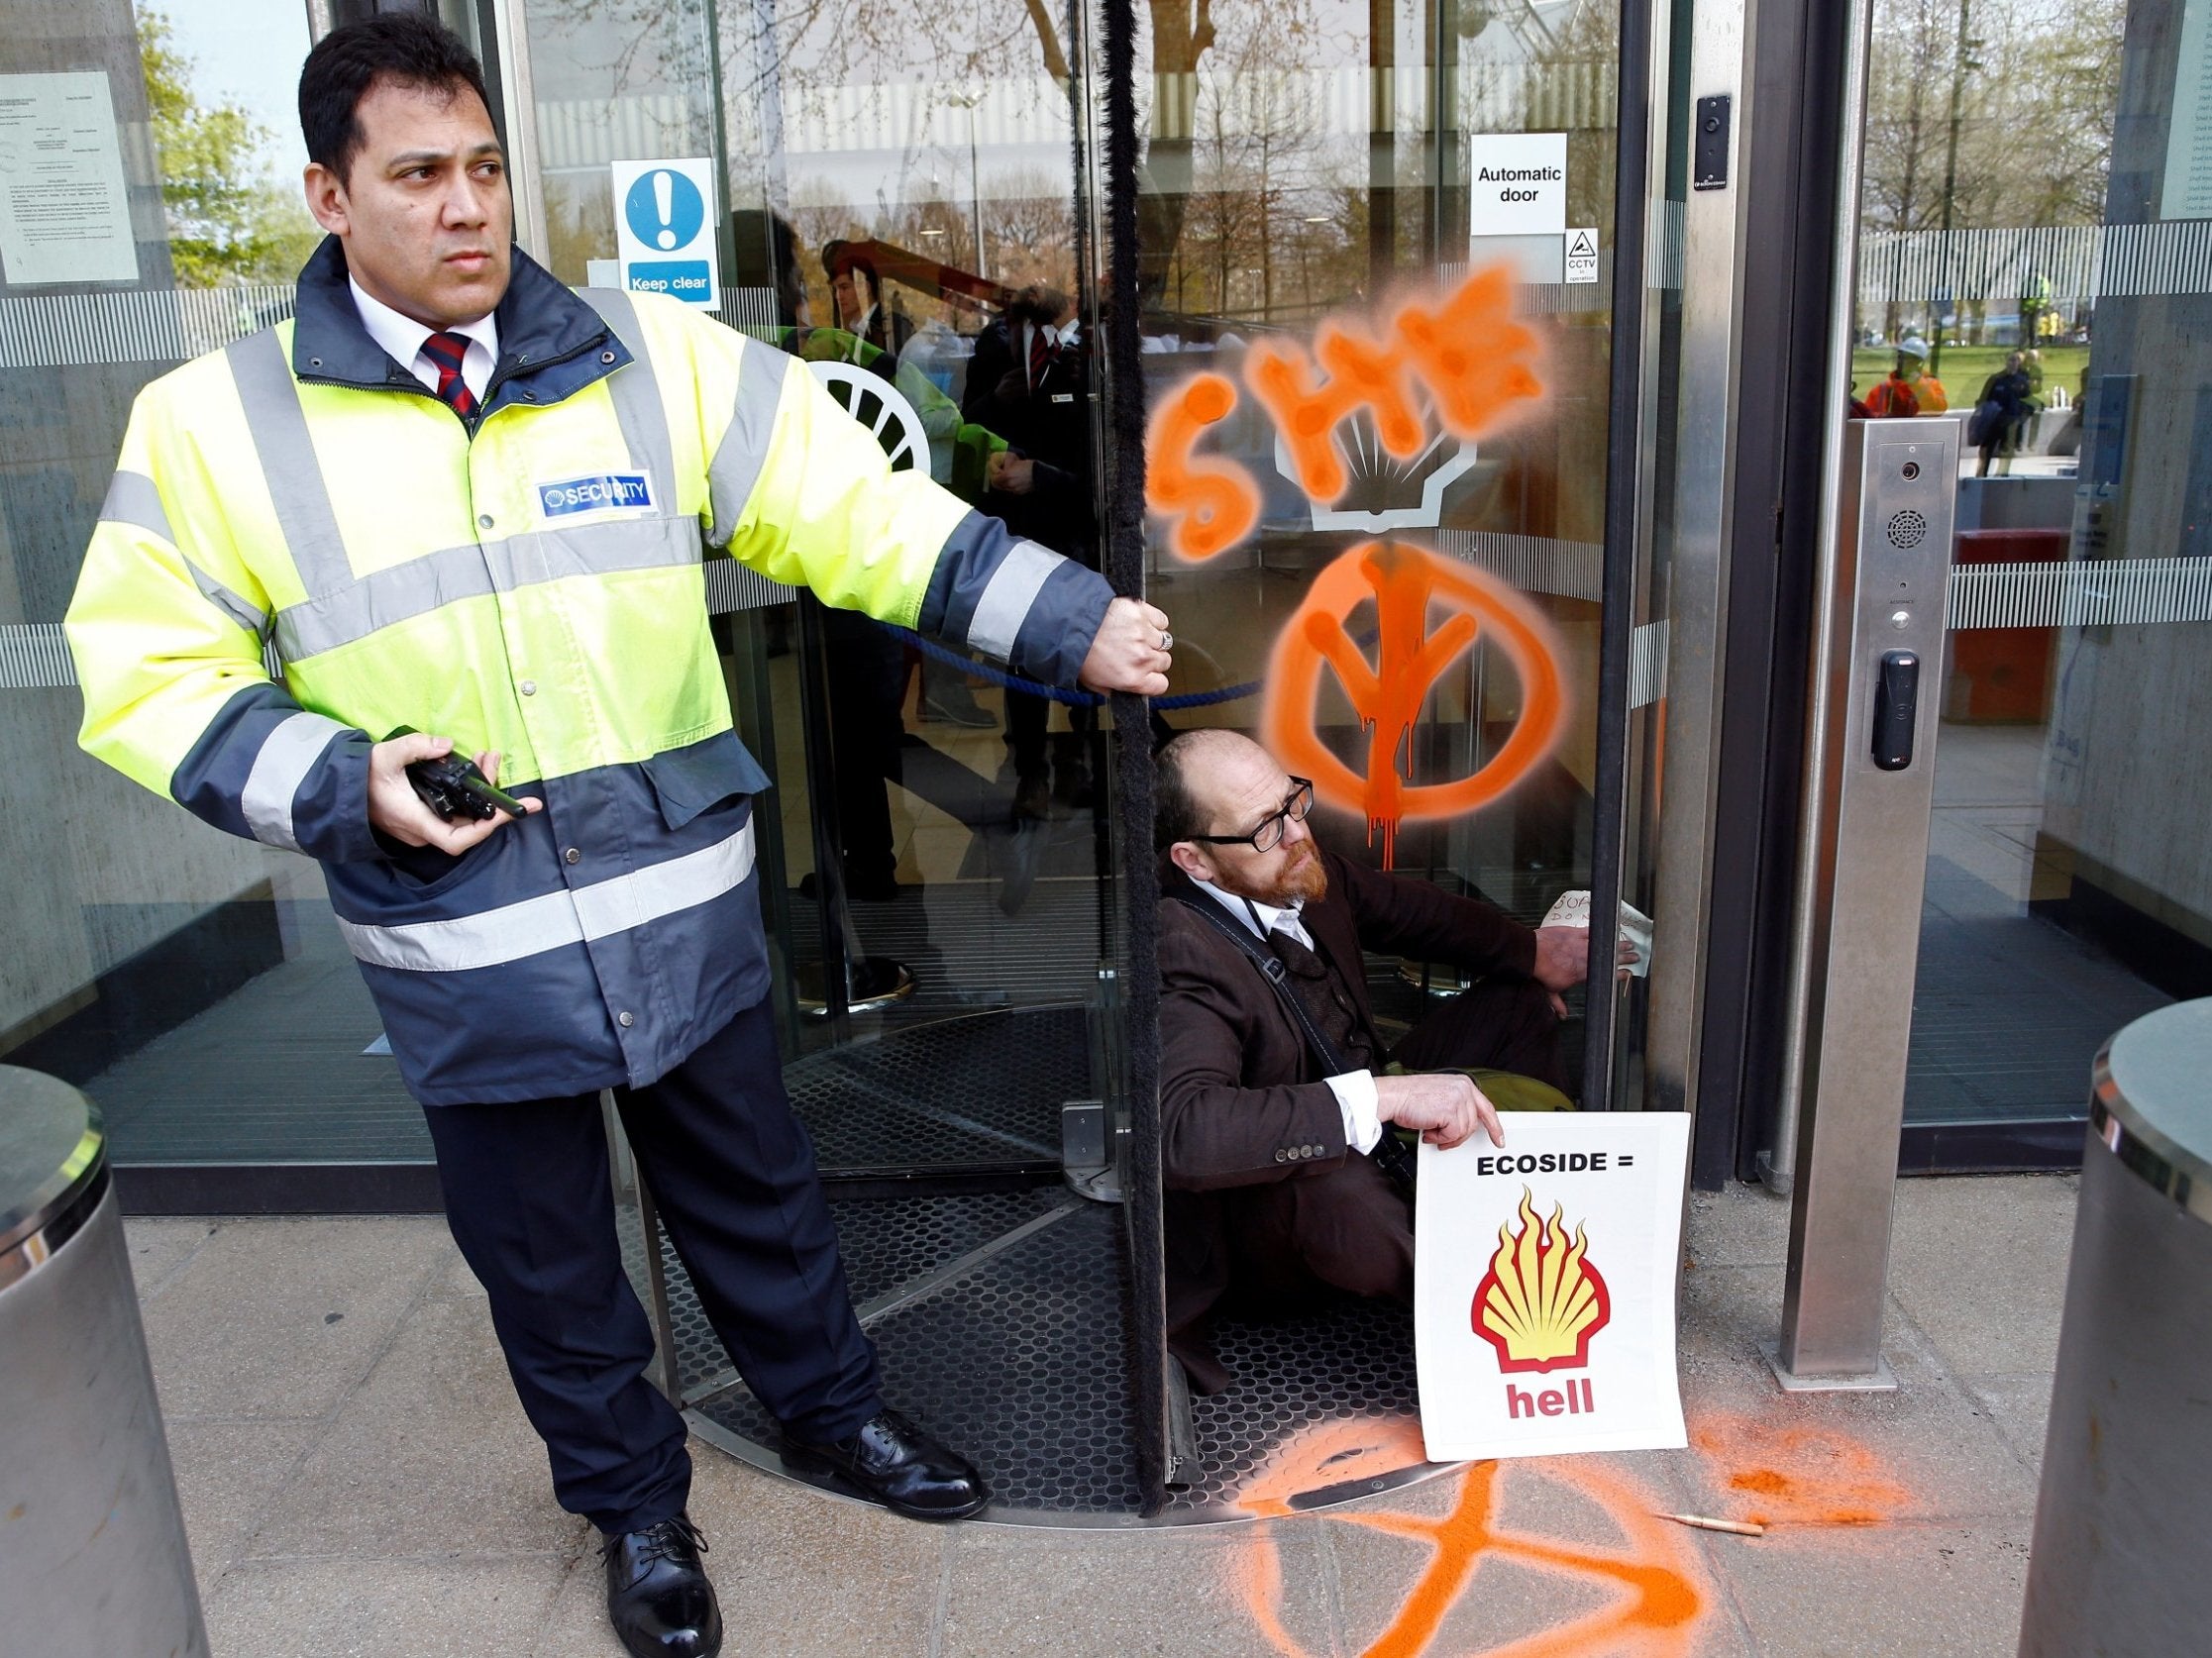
1889, 1174, 2079, 1373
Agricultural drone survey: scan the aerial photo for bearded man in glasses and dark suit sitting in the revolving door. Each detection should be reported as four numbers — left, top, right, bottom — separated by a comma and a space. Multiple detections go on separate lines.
1155, 730, 1591, 1393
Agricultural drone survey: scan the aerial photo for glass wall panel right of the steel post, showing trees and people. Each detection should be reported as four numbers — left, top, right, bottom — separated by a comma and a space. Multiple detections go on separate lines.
1851, 0, 2212, 1154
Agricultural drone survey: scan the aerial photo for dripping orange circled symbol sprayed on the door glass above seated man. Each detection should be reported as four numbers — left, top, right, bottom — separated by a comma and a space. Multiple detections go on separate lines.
1263, 542, 1566, 869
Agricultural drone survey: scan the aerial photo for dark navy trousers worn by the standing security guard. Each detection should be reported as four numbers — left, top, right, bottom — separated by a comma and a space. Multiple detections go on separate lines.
425, 1001, 881, 1532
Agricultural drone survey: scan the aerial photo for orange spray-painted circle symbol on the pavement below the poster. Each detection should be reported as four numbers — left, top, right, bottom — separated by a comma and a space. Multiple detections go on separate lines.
1241, 1421, 1706, 1658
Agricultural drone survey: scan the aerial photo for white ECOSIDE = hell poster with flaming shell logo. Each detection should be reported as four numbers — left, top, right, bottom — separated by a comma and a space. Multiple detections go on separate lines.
1414, 1112, 1690, 1461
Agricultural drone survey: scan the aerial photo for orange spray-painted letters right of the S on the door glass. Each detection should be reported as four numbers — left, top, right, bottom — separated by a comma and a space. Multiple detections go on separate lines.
1245, 265, 1544, 502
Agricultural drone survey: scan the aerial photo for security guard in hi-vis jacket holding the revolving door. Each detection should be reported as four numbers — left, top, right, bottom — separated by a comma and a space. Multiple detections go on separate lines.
68, 13, 1170, 1654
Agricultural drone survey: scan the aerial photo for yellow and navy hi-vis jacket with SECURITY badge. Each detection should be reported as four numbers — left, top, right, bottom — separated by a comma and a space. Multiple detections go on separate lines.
66, 239, 1110, 1105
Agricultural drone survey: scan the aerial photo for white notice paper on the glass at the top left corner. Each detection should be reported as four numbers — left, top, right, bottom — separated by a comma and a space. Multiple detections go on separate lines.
0, 70, 140, 285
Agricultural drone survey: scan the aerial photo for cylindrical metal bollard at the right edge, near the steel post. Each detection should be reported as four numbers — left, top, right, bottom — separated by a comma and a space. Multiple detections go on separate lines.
2020, 999, 2212, 1658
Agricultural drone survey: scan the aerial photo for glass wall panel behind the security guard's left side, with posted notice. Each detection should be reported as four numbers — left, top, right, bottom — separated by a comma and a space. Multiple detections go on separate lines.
0, 0, 429, 1165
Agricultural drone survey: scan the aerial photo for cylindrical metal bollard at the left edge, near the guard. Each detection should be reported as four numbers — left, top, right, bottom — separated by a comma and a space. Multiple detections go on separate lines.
0, 1066, 208, 1658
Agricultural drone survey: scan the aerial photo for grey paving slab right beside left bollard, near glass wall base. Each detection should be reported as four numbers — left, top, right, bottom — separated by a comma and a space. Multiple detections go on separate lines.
144, 1216, 454, 1419
